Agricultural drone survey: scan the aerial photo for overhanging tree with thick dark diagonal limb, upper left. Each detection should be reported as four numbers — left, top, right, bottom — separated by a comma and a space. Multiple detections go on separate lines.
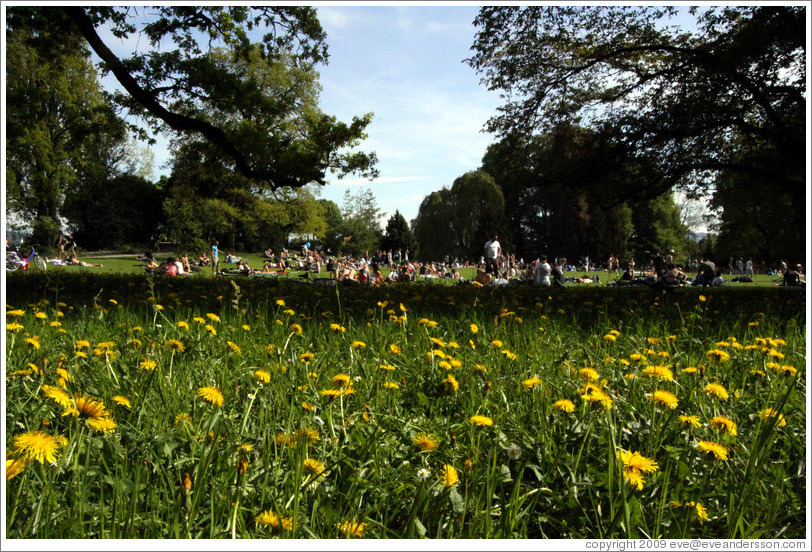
58, 6, 377, 190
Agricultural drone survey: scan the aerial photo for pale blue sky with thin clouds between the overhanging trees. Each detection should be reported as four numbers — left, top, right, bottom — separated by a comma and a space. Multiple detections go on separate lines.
318, 4, 500, 222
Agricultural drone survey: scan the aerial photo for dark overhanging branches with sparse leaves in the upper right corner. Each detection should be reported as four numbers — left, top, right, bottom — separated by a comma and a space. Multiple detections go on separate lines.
468, 5, 808, 212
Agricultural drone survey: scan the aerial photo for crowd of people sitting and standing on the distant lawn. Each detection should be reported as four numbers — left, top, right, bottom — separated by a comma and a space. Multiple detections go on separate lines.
127, 235, 805, 287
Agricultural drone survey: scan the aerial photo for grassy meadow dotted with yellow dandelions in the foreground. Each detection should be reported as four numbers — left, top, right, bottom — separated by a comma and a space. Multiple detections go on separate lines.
5, 269, 807, 539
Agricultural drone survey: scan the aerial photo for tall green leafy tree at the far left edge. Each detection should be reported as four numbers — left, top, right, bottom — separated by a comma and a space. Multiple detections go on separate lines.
6, 7, 126, 245
